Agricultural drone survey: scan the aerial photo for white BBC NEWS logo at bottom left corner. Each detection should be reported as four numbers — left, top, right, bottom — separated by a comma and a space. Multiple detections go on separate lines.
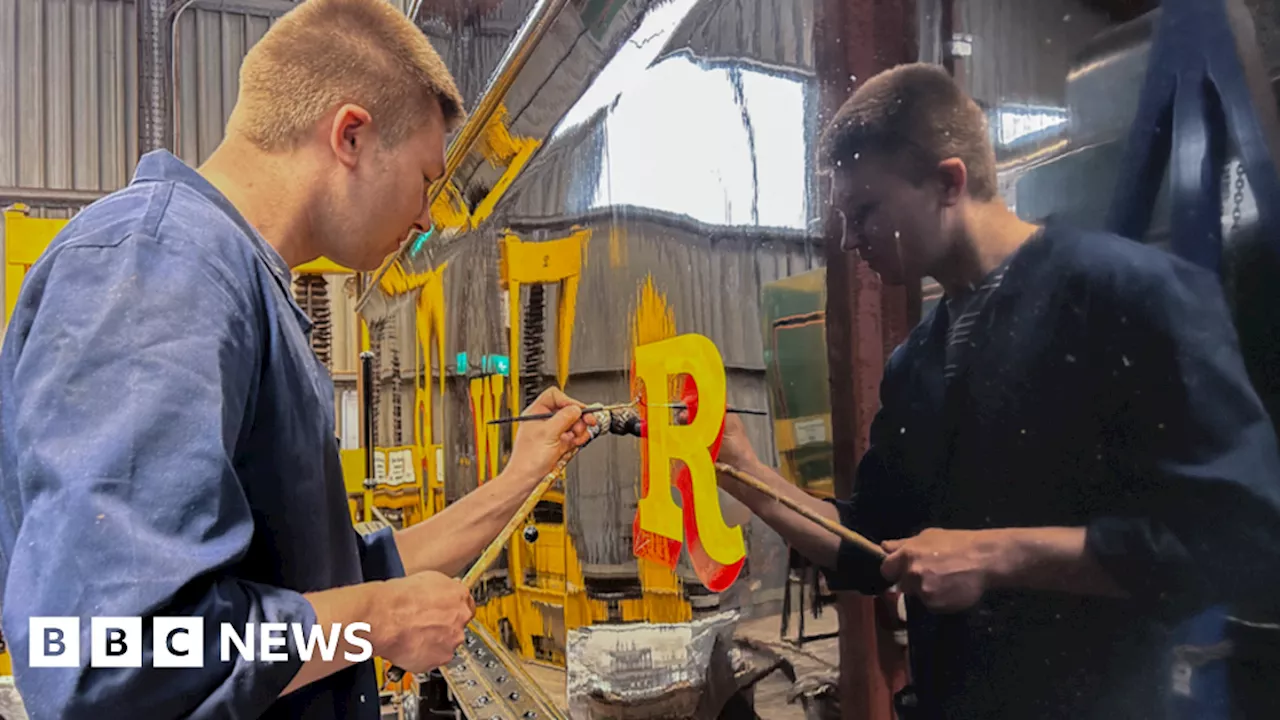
28, 618, 374, 667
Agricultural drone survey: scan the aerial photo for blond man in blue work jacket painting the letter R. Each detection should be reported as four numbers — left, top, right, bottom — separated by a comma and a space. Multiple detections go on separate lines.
0, 0, 586, 720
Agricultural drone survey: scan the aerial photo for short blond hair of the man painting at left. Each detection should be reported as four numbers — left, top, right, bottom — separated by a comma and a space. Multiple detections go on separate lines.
230, 0, 465, 151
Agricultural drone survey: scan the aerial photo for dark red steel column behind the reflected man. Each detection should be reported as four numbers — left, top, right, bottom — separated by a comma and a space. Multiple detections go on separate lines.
814, 0, 920, 720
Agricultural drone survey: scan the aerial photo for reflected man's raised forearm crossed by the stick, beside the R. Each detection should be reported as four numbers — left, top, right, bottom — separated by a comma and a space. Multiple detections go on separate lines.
721, 462, 840, 568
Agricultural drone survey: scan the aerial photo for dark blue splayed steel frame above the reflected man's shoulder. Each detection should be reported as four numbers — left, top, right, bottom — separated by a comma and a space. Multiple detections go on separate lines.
1107, 0, 1280, 272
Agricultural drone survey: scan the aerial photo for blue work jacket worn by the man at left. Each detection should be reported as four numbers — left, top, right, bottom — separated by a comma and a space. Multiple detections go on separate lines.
0, 151, 404, 720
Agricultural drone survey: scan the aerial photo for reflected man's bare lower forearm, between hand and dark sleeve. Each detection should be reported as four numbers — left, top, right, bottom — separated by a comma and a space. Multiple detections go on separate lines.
984, 528, 1126, 597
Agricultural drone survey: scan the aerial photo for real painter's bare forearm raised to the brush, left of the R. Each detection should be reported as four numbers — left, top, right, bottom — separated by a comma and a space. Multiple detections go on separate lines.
396, 471, 540, 577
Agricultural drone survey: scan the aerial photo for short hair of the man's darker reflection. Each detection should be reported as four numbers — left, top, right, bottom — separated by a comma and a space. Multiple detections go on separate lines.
822, 63, 998, 201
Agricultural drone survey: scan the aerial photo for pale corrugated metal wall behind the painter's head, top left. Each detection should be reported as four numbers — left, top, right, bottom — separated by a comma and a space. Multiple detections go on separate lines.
0, 0, 298, 215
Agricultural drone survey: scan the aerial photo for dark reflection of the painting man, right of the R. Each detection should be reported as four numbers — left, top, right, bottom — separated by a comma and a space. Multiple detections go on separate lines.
721, 65, 1280, 720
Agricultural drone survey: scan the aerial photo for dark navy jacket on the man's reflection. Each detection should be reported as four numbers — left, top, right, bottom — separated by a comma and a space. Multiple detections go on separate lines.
828, 225, 1280, 720
